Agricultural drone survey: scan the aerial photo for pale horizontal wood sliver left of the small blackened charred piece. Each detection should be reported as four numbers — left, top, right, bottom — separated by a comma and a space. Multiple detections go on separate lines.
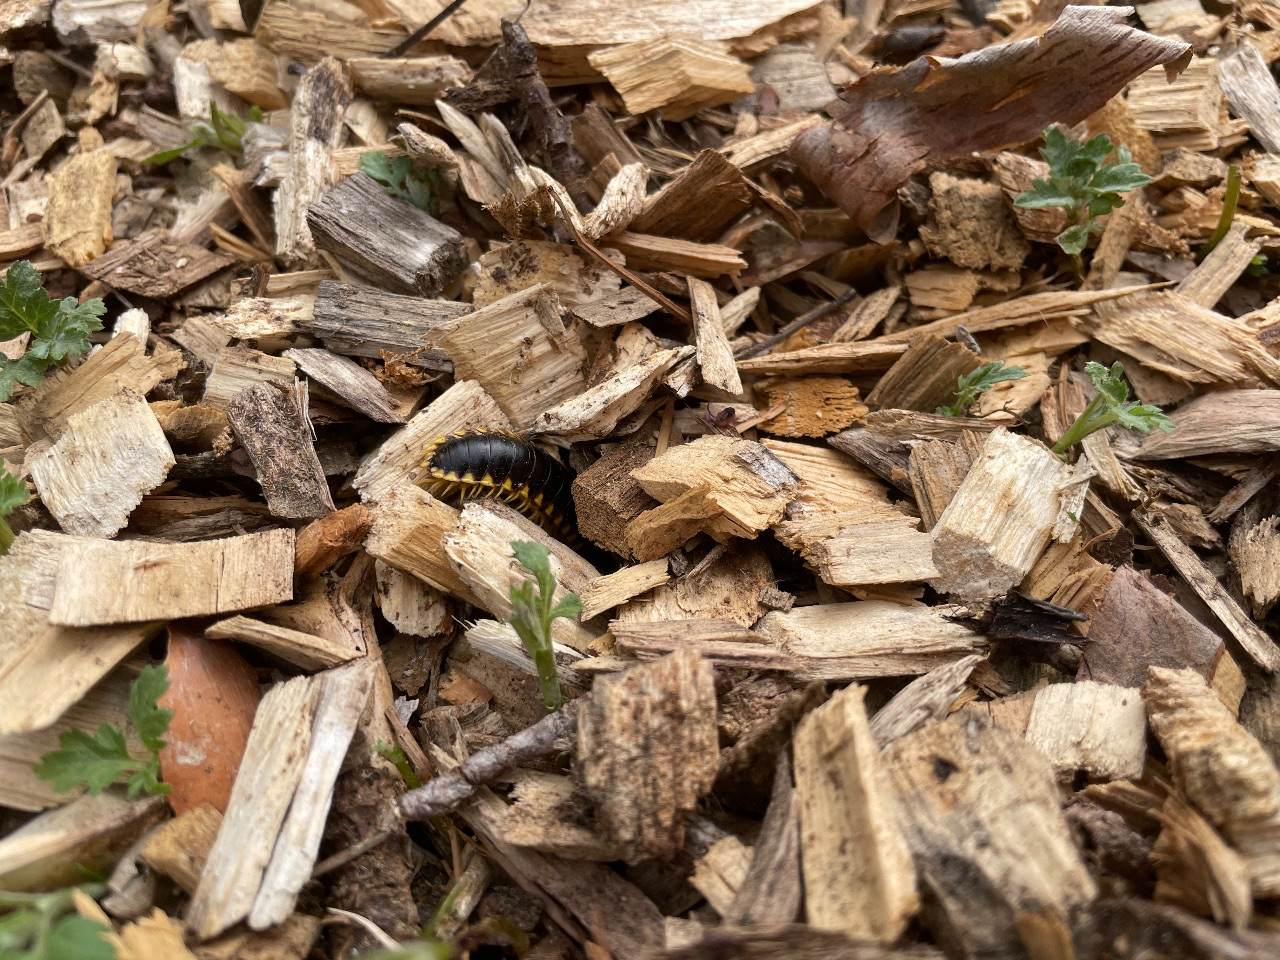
756, 600, 986, 681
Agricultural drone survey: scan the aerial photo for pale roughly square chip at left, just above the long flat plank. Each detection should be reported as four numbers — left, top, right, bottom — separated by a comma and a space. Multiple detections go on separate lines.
26, 388, 175, 538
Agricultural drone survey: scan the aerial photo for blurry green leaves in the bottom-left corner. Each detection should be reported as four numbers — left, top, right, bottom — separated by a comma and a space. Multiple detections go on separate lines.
0, 883, 115, 960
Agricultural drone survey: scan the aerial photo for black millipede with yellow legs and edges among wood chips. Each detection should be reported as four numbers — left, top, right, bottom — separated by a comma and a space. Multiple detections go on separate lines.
421, 430, 577, 543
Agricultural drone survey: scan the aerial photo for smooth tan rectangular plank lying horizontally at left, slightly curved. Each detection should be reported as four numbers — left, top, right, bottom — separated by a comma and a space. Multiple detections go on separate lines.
49, 530, 293, 626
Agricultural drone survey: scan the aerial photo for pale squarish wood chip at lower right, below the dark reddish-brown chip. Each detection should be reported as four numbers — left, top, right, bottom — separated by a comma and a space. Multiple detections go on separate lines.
1027, 680, 1147, 782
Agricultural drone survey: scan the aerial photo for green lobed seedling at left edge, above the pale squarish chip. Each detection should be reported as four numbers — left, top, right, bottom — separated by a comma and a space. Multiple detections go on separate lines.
0, 260, 106, 402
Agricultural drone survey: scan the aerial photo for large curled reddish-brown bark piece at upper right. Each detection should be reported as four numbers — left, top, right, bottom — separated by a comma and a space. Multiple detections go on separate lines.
790, 6, 1190, 243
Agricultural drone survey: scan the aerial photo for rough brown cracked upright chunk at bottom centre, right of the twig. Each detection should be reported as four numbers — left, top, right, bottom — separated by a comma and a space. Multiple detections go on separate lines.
577, 649, 719, 863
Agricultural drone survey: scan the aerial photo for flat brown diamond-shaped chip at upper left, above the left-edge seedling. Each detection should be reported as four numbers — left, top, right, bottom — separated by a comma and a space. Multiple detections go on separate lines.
79, 229, 236, 300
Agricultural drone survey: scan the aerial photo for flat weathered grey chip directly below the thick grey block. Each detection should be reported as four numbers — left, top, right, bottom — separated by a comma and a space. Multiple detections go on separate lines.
307, 280, 468, 370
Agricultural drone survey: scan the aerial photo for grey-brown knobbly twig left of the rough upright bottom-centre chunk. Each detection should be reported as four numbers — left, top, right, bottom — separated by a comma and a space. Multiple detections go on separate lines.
396, 696, 585, 820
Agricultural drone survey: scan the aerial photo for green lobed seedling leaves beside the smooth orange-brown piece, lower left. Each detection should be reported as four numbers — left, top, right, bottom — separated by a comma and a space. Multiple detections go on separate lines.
36, 666, 173, 800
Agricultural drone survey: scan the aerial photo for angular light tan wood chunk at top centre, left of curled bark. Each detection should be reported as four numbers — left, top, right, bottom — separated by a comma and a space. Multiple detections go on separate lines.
588, 33, 754, 120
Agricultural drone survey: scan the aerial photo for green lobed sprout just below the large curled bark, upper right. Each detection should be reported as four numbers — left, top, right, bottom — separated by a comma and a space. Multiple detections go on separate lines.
1014, 127, 1151, 266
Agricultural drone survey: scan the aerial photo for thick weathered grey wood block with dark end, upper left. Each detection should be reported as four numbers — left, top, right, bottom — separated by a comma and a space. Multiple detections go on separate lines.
307, 170, 467, 297
